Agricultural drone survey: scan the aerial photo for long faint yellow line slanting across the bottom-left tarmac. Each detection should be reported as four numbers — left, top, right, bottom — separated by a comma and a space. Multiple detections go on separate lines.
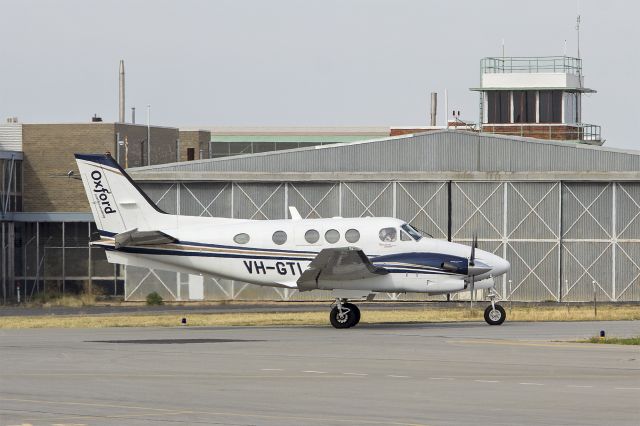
0, 397, 427, 426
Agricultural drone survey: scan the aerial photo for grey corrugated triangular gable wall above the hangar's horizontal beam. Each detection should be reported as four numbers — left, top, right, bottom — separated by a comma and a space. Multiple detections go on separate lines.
135, 130, 640, 173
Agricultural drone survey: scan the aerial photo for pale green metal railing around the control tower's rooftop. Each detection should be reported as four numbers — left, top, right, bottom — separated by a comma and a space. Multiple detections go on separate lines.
480, 56, 582, 75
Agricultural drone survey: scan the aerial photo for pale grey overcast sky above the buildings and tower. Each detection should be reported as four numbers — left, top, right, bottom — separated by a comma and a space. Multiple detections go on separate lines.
0, 0, 640, 149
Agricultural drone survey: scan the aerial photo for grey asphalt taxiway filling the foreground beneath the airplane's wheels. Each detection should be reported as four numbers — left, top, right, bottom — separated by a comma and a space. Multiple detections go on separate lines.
0, 321, 640, 425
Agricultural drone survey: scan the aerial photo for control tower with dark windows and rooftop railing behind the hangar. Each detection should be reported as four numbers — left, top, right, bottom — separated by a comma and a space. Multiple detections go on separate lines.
471, 56, 603, 145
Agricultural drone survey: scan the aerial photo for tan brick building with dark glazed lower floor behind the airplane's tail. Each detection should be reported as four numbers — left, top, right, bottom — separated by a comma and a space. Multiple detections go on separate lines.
0, 119, 210, 301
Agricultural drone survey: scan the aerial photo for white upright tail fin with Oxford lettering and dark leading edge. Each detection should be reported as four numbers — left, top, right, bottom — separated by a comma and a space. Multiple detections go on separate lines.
75, 154, 166, 234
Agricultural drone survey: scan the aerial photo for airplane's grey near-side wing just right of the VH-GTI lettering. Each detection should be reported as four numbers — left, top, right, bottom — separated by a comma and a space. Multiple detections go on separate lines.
297, 247, 389, 290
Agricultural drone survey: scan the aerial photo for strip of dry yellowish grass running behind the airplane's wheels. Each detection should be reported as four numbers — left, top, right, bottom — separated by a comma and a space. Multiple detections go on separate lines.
0, 306, 640, 328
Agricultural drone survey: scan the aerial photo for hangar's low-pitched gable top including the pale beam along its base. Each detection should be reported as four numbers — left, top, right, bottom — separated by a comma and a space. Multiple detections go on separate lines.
130, 130, 640, 181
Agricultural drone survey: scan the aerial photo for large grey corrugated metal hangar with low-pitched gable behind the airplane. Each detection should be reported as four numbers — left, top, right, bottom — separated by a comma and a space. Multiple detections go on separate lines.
125, 130, 640, 301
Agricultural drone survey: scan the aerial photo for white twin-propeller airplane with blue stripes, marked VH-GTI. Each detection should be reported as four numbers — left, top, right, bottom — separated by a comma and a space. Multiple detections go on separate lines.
75, 154, 510, 328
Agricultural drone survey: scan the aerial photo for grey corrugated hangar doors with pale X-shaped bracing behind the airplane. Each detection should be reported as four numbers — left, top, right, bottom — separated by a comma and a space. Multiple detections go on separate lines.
126, 181, 640, 301
